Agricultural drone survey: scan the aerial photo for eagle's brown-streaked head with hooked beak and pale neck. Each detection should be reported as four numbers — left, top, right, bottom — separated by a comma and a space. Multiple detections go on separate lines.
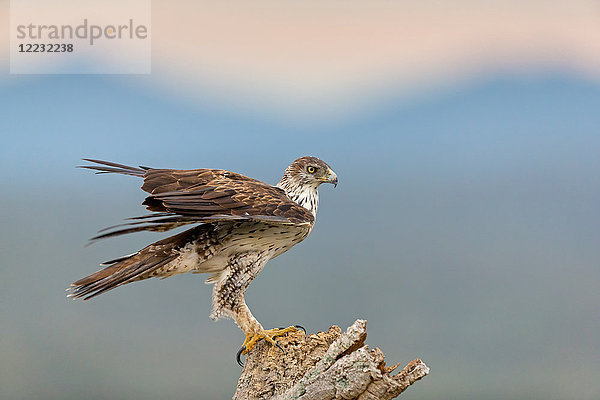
277, 156, 338, 216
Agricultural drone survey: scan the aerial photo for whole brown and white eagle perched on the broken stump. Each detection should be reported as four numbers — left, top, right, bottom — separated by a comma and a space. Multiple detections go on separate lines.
69, 156, 338, 362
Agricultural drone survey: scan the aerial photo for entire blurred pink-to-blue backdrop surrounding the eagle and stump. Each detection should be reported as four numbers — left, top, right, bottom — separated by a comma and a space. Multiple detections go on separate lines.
0, 1, 600, 400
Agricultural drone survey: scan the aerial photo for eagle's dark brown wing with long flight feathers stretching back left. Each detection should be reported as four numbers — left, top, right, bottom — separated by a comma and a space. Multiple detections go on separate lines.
83, 159, 314, 240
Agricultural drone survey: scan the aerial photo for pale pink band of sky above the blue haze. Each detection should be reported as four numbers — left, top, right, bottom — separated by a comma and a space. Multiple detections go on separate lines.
0, 0, 600, 117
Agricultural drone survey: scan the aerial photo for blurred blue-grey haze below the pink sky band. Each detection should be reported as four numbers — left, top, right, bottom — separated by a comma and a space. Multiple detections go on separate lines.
0, 75, 600, 400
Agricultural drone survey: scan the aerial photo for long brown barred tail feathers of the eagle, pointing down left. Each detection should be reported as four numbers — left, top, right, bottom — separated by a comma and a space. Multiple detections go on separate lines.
67, 225, 210, 300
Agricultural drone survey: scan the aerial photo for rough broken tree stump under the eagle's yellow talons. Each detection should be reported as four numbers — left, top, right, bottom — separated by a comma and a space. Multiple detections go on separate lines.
233, 319, 429, 400
